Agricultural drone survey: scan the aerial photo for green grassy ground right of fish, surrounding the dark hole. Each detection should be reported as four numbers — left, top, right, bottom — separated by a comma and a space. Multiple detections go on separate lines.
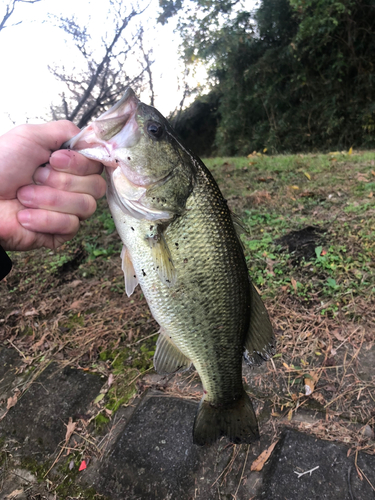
205, 152, 375, 315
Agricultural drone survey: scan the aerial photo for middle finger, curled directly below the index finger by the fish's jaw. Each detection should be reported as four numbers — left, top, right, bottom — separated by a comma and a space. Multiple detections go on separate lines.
34, 165, 106, 200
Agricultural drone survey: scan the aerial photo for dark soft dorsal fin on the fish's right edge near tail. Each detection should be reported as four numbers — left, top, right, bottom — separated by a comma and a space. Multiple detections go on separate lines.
244, 283, 276, 365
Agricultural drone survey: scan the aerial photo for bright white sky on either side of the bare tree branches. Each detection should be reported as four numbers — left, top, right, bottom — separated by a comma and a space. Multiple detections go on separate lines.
0, 0, 205, 134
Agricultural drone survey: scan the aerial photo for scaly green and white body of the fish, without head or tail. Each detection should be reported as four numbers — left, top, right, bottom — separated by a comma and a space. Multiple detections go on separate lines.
111, 167, 250, 403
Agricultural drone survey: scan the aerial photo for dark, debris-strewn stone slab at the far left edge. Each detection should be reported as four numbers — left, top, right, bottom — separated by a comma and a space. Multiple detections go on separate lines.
0, 363, 104, 460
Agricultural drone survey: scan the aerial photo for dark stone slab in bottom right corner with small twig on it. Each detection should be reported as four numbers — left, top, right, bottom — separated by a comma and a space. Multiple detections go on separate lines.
257, 429, 375, 500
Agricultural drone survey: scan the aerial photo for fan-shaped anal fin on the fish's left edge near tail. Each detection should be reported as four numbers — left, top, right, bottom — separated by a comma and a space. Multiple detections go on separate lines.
154, 330, 191, 375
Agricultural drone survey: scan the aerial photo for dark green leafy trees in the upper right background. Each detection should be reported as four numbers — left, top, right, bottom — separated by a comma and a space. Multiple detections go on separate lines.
164, 0, 375, 155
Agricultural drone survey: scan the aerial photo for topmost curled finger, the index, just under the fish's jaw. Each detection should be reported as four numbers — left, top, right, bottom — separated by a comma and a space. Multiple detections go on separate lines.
49, 149, 103, 175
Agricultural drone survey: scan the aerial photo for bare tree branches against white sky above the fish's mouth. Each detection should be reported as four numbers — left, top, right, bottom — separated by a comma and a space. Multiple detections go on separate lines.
49, 0, 154, 127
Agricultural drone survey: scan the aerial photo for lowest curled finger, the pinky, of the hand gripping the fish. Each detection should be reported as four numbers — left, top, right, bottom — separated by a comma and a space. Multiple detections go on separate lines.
17, 209, 79, 237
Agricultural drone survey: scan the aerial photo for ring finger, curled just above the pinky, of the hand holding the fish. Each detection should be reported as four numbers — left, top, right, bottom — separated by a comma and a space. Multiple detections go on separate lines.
17, 184, 96, 220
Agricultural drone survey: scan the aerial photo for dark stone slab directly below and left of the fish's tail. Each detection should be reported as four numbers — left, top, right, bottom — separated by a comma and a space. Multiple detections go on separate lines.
84, 395, 266, 500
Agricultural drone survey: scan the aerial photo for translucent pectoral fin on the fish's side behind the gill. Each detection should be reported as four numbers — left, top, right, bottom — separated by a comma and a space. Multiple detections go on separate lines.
147, 225, 176, 287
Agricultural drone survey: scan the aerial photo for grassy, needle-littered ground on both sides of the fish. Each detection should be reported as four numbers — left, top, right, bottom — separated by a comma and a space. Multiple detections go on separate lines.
0, 152, 375, 480
